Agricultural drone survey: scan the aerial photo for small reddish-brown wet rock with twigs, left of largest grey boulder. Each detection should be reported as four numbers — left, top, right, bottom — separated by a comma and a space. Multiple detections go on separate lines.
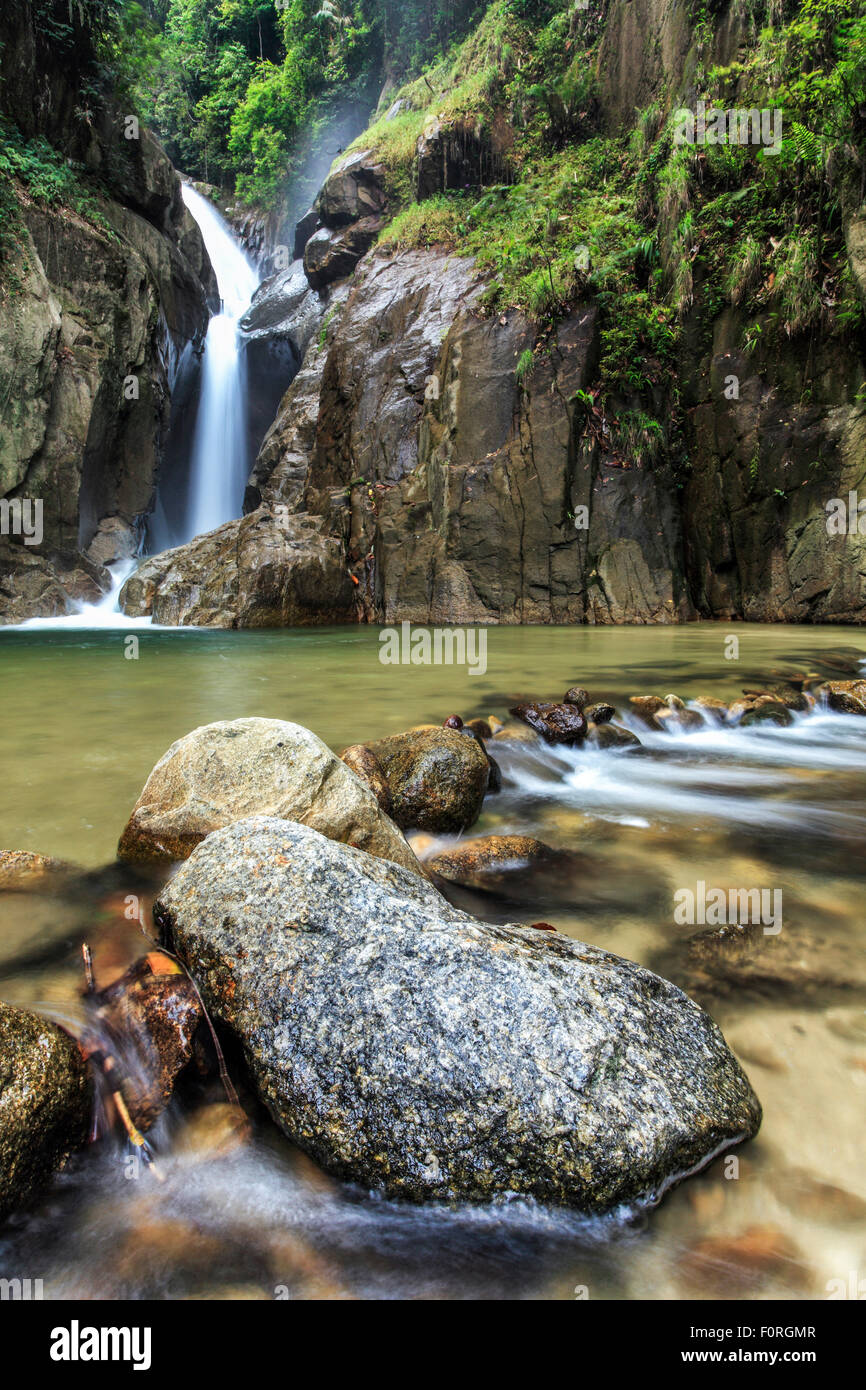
88, 952, 204, 1130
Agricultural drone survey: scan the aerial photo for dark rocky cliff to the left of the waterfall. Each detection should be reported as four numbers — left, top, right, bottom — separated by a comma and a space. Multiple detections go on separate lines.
0, 0, 215, 621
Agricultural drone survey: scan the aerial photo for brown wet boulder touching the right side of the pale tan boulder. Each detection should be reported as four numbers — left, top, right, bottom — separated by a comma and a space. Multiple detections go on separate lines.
366, 728, 489, 834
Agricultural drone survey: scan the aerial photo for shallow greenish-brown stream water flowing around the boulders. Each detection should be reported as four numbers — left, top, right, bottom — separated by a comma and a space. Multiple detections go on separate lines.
0, 626, 866, 1298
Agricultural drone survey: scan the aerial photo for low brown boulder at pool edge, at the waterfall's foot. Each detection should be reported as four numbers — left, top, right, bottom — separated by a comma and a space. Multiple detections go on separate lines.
120, 507, 354, 628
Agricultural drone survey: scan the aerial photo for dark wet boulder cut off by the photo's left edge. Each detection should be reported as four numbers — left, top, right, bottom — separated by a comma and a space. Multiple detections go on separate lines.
0, 1004, 92, 1220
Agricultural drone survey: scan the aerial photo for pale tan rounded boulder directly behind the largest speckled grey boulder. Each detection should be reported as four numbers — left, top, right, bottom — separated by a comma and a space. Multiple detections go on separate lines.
118, 719, 421, 874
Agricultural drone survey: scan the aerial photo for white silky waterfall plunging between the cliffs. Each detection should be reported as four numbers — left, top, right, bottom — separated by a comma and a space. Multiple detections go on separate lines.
179, 183, 259, 541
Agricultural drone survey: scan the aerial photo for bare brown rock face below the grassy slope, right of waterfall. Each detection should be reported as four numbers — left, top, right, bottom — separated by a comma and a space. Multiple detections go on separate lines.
250, 250, 692, 623
